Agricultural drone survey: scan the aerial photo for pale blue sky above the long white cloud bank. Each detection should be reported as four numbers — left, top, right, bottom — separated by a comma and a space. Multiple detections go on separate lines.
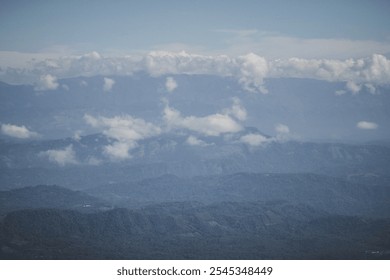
0, 0, 390, 57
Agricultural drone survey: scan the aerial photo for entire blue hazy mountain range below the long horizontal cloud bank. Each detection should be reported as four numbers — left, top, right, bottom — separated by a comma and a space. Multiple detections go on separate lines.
0, 72, 390, 259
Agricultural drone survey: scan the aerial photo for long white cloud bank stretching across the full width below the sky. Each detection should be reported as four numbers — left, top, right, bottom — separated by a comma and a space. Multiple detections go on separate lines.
0, 51, 390, 93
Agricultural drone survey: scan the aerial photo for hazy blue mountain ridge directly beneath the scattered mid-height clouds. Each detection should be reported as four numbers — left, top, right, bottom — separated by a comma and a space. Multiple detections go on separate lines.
0, 132, 390, 189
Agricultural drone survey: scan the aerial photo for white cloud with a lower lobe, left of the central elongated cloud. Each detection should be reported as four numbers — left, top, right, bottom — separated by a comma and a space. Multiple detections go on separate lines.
84, 112, 161, 160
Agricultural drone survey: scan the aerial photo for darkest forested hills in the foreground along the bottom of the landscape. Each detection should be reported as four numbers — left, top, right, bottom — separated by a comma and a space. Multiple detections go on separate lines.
1, 201, 390, 259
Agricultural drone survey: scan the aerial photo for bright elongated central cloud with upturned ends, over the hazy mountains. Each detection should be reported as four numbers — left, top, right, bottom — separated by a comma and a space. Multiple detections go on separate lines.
164, 100, 246, 136
